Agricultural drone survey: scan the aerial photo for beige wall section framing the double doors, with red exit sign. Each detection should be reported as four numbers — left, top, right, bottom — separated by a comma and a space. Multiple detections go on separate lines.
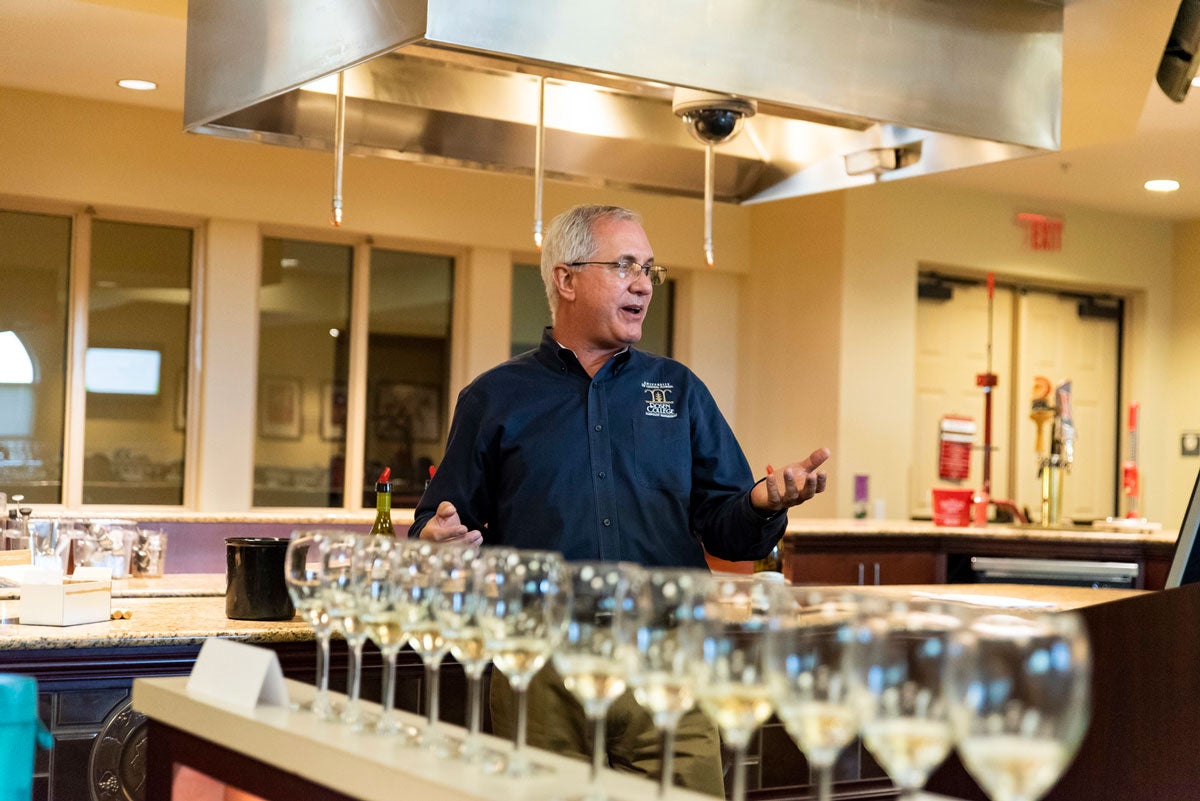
839, 180, 1182, 525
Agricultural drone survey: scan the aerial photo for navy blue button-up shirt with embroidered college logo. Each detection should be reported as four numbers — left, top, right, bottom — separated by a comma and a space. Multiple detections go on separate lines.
408, 329, 787, 567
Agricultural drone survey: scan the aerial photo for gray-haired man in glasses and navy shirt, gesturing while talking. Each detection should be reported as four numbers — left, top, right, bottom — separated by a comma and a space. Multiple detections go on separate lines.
409, 206, 829, 795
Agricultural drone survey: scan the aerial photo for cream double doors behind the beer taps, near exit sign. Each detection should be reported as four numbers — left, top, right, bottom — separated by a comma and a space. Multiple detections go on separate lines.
910, 284, 1126, 522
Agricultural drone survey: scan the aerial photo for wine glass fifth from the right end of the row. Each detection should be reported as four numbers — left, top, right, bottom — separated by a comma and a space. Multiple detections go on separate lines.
629, 568, 712, 799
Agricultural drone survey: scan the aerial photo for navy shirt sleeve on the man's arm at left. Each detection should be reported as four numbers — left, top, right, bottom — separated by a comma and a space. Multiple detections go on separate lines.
408, 387, 494, 541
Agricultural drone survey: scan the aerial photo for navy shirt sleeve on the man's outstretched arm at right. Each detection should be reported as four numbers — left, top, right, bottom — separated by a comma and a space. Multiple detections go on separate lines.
691, 378, 787, 561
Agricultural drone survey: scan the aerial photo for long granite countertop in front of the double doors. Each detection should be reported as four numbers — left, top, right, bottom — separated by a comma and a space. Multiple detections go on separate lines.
785, 518, 1178, 546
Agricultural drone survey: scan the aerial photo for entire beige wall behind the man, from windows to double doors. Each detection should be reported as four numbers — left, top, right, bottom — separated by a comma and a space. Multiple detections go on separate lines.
0, 89, 1200, 525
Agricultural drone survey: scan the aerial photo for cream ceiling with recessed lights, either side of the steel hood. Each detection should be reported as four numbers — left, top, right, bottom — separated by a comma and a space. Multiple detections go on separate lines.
7, 0, 1200, 221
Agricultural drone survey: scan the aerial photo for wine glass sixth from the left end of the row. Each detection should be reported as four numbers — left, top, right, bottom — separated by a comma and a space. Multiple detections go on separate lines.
479, 548, 570, 777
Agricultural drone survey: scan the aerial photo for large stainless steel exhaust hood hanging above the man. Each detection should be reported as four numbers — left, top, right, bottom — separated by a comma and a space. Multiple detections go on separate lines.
184, 0, 1063, 203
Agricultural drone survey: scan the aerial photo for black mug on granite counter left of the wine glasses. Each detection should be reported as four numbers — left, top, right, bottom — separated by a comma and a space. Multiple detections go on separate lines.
226, 537, 295, 620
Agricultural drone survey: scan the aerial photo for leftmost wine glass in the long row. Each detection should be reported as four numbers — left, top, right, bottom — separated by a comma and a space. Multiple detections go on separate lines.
283, 530, 343, 721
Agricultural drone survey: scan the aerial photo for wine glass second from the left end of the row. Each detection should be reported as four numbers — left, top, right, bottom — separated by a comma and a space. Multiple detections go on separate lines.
320, 534, 368, 729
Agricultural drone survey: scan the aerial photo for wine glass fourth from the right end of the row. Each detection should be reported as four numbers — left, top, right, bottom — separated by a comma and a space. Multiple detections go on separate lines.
696, 578, 796, 801
